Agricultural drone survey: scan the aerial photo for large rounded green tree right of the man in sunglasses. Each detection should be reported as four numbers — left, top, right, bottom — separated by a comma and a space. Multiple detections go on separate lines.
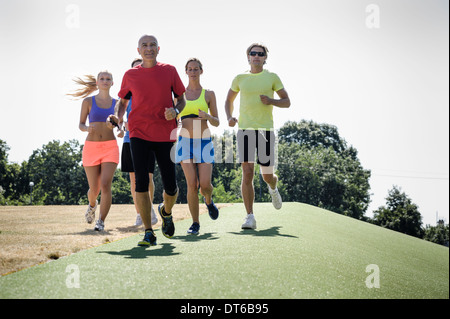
278, 121, 370, 219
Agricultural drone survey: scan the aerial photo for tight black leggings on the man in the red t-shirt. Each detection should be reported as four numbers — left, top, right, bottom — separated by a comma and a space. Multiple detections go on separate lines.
130, 137, 178, 196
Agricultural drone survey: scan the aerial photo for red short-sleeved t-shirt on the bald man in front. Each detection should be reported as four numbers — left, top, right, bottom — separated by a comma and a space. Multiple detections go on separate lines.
119, 62, 186, 142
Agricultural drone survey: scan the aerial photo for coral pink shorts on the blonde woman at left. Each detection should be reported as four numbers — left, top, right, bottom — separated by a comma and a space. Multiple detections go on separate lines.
83, 140, 119, 166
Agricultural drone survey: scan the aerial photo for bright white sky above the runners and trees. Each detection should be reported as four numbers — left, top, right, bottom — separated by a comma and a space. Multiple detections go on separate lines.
0, 0, 449, 225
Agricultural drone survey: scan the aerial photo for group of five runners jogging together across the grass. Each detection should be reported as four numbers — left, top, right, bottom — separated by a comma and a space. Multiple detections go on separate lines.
73, 35, 290, 246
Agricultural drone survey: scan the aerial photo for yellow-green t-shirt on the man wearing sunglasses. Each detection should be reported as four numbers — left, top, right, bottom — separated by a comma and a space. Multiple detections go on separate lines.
231, 70, 284, 130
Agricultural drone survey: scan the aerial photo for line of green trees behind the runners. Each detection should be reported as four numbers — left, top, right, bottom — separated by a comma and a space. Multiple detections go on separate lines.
0, 120, 449, 245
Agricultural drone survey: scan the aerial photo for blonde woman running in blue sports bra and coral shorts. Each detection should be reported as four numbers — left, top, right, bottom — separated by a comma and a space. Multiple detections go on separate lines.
70, 71, 123, 231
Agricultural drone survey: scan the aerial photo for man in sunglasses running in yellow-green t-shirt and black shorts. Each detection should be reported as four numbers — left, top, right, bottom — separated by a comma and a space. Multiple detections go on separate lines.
225, 43, 291, 229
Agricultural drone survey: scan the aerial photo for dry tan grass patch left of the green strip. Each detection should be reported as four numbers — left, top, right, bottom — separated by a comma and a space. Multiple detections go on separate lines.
0, 204, 229, 275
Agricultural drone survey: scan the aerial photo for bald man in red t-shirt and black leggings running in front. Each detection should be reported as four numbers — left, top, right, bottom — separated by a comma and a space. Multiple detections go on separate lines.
107, 35, 186, 246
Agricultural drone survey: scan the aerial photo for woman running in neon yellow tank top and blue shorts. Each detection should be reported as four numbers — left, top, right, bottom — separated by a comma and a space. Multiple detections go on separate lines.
175, 58, 219, 235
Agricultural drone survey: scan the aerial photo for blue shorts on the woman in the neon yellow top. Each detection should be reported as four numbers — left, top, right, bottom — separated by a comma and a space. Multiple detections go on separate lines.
175, 136, 214, 164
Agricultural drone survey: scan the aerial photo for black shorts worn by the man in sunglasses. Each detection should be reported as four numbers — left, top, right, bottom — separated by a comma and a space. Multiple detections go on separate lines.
237, 130, 275, 166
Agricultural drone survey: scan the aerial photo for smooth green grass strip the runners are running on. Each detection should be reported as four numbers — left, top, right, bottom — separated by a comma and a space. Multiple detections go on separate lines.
0, 203, 449, 299
